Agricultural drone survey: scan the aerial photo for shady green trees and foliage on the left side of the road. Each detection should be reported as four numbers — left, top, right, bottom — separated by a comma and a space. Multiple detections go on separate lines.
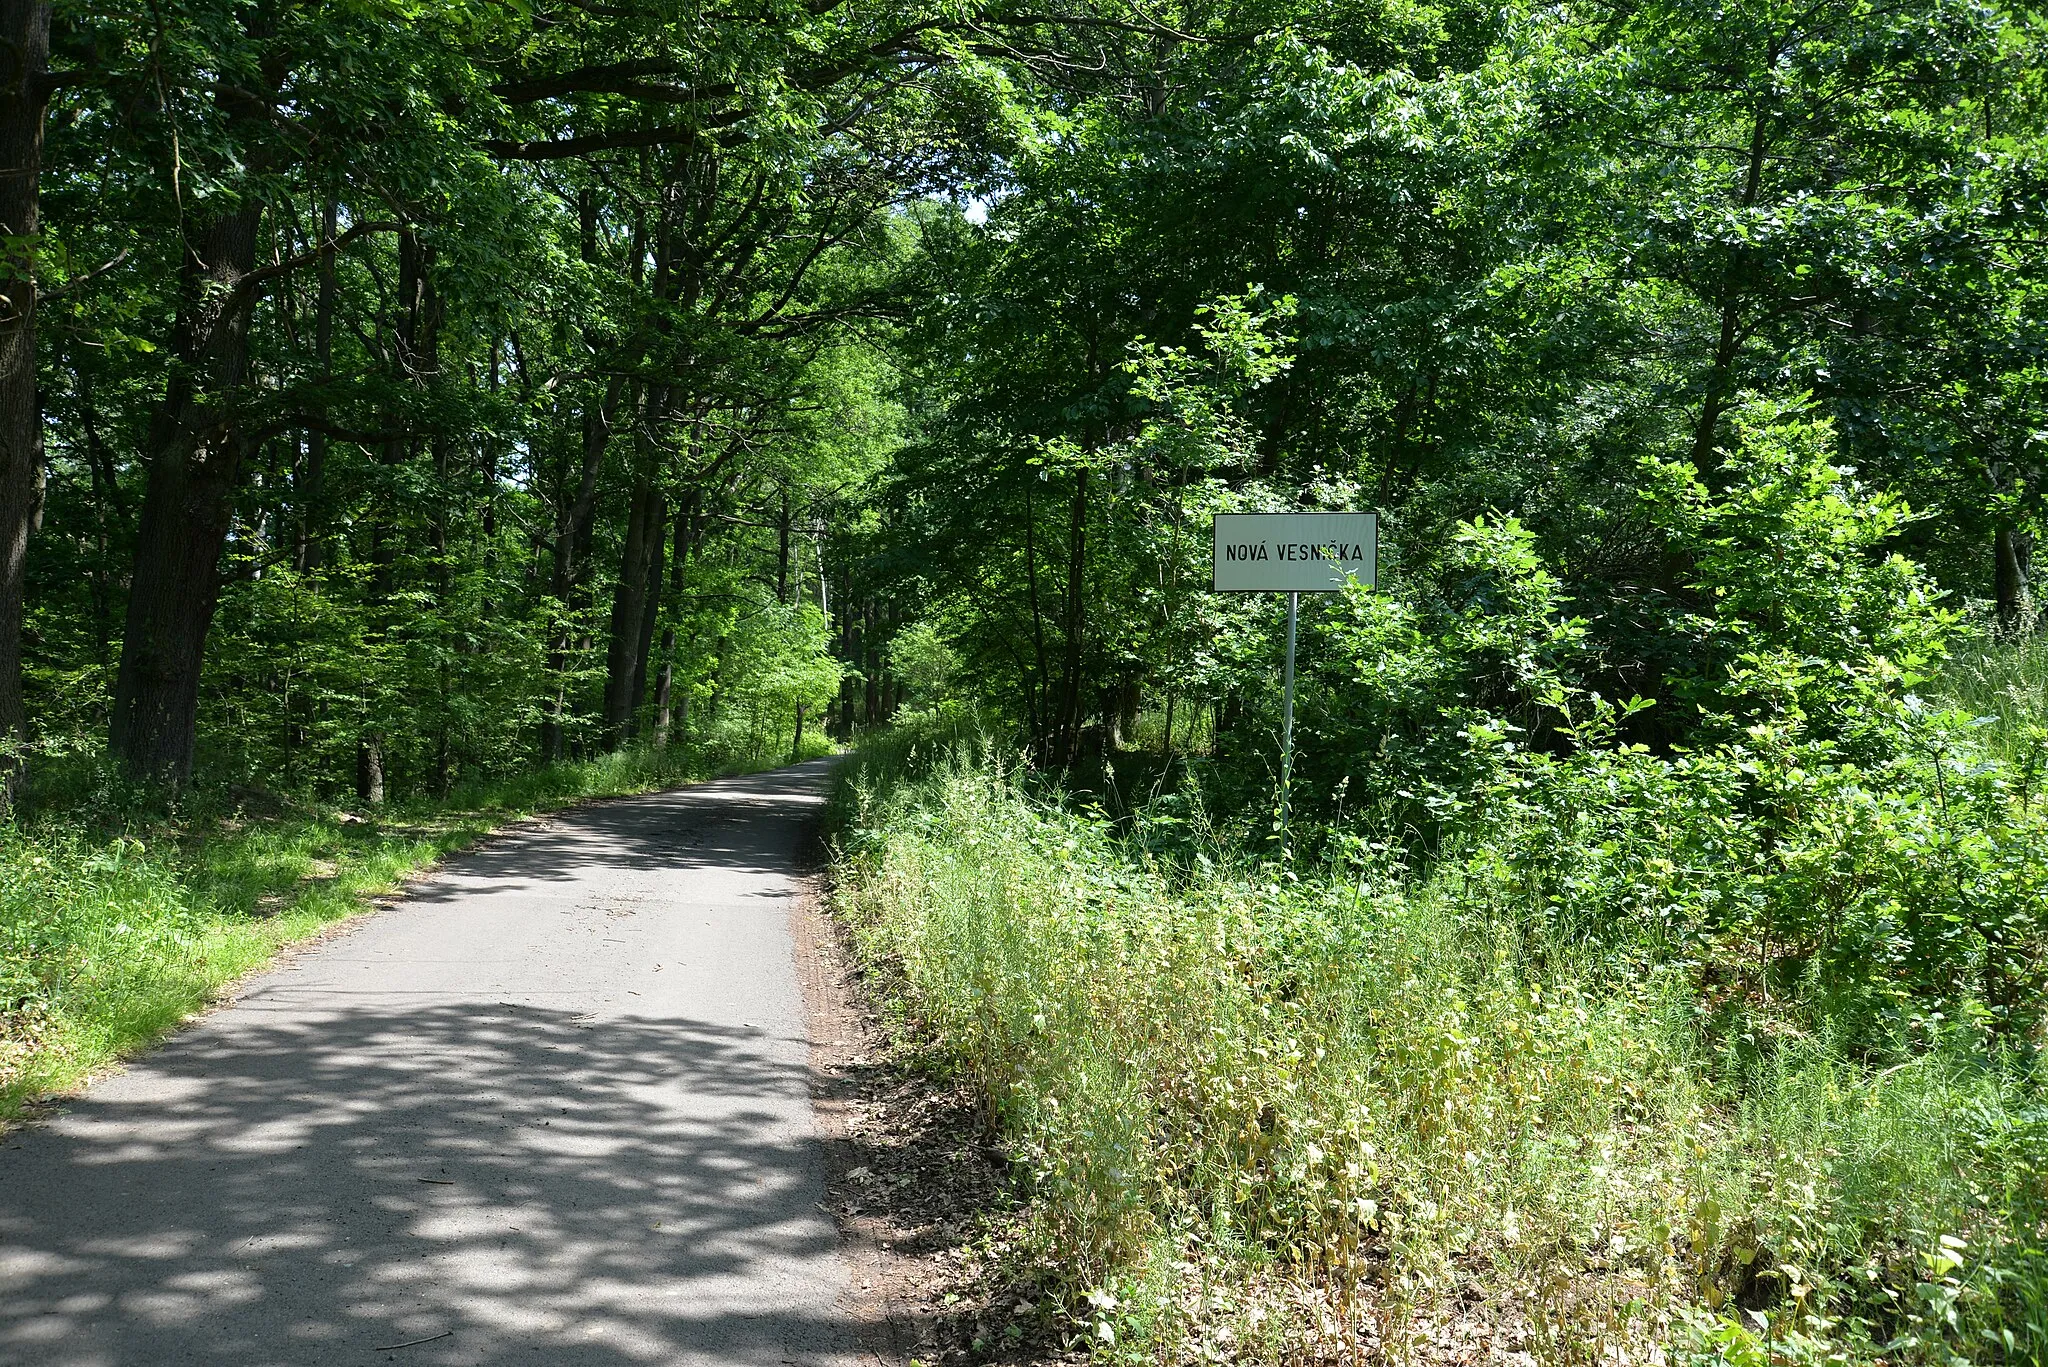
22, 0, 921, 799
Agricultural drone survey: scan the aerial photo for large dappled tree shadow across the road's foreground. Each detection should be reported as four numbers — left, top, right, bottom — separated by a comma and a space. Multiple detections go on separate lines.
0, 1004, 846, 1367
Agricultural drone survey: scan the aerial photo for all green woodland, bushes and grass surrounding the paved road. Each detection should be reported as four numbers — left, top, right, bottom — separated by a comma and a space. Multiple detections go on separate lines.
0, 0, 2048, 1367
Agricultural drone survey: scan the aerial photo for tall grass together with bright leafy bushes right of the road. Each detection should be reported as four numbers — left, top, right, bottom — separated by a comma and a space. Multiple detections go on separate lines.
842, 362, 2048, 1363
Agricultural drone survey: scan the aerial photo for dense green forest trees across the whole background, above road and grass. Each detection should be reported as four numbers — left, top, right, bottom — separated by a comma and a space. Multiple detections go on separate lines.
0, 0, 2048, 801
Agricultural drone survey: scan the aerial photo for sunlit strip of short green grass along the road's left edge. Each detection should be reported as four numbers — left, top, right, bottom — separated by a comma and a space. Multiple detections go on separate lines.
0, 748, 831, 1121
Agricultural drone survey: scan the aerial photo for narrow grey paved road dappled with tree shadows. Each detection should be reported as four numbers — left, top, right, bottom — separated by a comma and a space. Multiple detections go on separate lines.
0, 760, 854, 1367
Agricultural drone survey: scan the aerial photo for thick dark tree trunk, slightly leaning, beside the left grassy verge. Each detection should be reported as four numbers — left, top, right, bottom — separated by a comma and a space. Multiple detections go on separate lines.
109, 209, 262, 785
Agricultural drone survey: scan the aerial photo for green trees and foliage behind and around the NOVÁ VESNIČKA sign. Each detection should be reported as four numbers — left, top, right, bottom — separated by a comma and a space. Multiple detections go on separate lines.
883, 2, 2048, 811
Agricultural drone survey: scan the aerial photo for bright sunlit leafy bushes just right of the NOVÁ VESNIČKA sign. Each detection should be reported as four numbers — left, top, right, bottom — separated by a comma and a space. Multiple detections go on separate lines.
1300, 389, 1968, 840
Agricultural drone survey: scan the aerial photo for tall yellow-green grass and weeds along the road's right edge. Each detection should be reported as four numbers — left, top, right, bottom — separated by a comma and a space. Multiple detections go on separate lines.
840, 717, 2048, 1367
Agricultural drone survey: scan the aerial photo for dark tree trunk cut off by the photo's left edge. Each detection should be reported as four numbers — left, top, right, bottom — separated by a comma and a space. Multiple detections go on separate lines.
0, 0, 49, 816
